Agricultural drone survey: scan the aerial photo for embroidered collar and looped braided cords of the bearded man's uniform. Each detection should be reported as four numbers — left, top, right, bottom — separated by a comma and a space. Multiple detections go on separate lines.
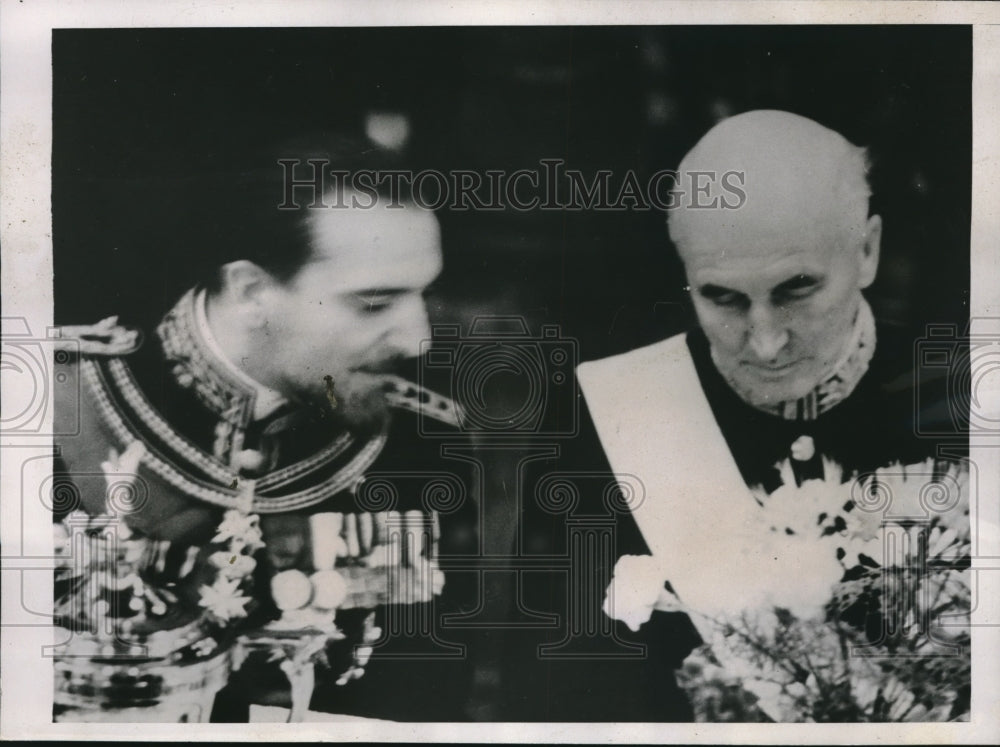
80, 290, 389, 514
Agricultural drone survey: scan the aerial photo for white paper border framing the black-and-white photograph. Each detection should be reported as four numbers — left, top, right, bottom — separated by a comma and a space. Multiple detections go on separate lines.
0, 0, 1000, 744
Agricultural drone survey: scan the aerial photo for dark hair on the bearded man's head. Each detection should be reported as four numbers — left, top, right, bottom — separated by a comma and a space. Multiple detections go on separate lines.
197, 133, 410, 291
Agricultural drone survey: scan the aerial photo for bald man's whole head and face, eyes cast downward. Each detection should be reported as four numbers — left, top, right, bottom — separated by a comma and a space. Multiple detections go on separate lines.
670, 111, 881, 406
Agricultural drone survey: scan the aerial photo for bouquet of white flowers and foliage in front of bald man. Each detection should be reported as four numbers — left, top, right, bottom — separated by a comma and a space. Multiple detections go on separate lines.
605, 460, 971, 722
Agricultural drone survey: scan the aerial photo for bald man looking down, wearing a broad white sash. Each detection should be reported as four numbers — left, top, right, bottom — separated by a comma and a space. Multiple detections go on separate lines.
515, 111, 961, 721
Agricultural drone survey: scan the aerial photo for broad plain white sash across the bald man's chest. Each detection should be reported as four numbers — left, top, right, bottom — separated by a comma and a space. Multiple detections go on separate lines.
577, 334, 759, 624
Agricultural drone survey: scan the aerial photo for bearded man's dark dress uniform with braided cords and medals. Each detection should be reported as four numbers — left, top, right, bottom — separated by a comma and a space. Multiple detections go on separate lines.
56, 289, 478, 721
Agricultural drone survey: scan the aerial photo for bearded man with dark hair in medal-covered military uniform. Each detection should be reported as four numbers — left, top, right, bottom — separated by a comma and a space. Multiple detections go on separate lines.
50, 139, 476, 721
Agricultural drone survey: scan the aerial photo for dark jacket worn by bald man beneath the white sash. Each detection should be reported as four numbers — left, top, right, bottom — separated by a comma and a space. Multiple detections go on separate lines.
504, 327, 968, 722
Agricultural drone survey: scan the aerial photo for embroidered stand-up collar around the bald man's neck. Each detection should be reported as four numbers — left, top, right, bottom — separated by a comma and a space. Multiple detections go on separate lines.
712, 298, 876, 420
